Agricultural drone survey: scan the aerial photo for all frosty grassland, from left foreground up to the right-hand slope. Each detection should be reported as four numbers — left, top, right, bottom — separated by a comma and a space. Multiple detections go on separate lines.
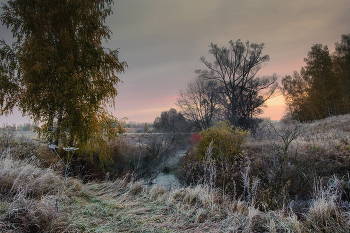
0, 115, 350, 232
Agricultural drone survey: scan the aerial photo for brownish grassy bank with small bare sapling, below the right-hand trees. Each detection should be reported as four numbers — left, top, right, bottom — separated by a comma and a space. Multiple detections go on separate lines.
244, 115, 350, 209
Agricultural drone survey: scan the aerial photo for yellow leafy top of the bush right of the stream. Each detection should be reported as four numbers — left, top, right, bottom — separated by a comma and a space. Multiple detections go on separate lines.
194, 121, 250, 162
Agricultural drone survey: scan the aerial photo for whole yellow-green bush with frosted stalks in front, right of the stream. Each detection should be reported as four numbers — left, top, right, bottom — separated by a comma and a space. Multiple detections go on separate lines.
178, 121, 249, 196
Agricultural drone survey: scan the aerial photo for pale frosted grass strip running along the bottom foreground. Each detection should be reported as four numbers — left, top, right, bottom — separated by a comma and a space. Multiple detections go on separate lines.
0, 158, 349, 232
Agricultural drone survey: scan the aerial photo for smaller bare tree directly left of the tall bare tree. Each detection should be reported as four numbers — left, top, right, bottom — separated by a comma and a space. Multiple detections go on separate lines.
176, 75, 222, 130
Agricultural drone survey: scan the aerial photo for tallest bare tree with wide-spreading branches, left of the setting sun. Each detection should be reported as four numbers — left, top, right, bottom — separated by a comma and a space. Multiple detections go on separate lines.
196, 40, 277, 128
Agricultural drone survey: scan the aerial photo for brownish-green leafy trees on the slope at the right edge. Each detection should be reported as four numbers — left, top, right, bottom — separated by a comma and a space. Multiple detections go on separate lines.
281, 34, 350, 122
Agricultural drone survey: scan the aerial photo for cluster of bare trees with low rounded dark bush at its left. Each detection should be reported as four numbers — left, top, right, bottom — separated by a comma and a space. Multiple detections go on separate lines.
154, 40, 278, 131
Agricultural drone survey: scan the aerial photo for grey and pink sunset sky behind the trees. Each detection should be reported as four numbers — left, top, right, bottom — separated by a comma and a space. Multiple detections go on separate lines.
0, 0, 350, 124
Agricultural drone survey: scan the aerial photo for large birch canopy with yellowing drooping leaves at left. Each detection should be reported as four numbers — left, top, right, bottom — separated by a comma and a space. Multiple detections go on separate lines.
0, 0, 127, 145
